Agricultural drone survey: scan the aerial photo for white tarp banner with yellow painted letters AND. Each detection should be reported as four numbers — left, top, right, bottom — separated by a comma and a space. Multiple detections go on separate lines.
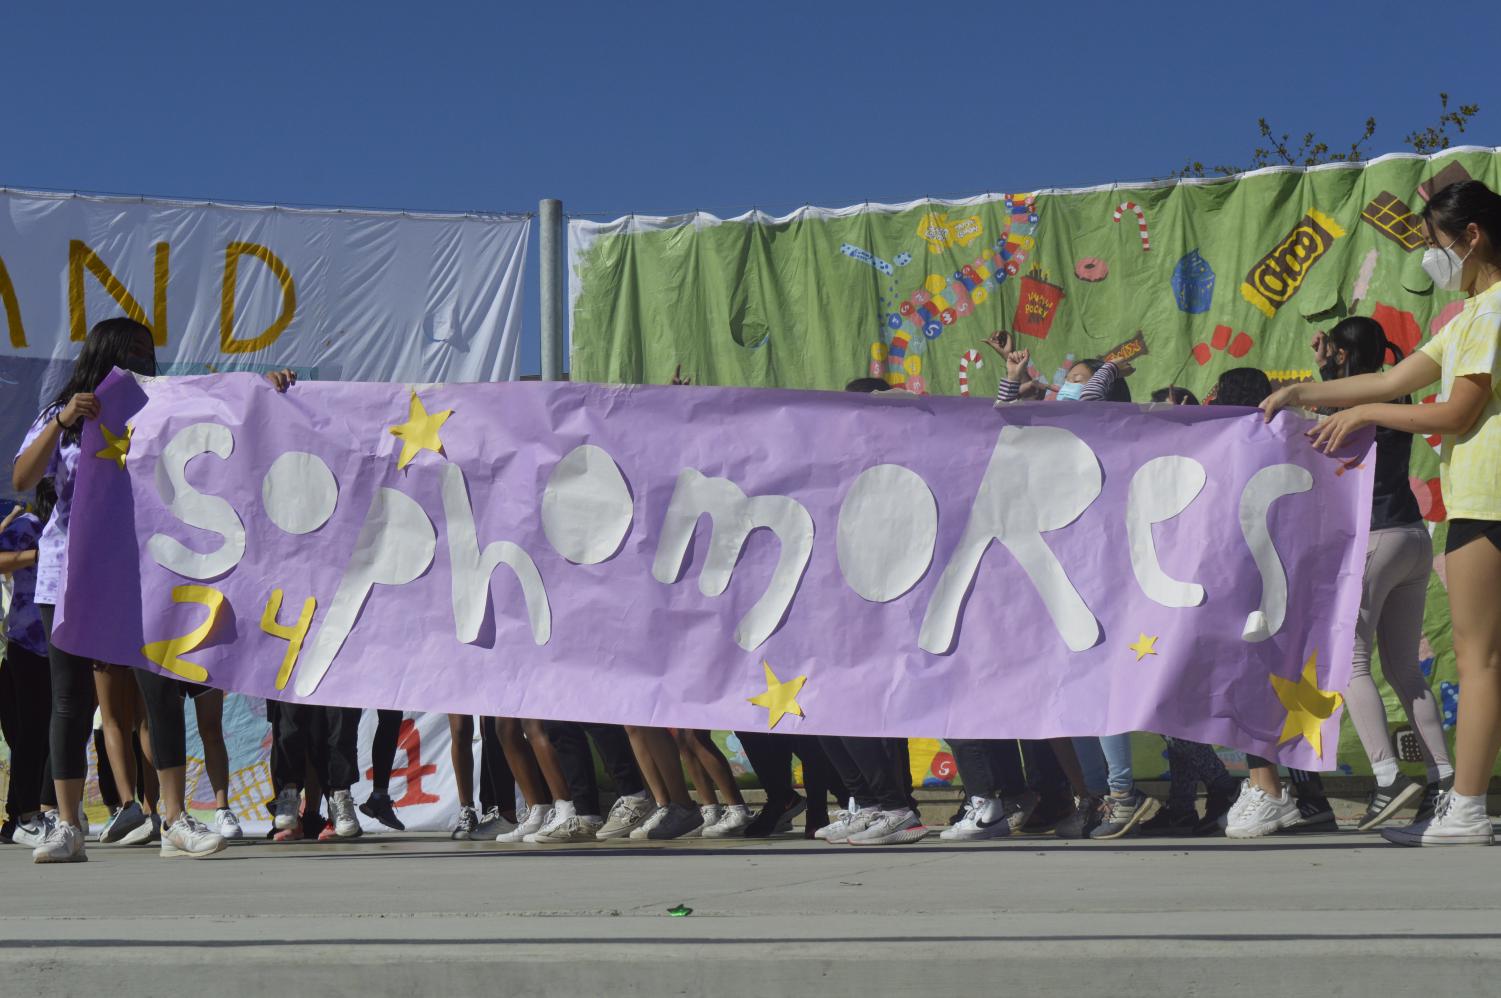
0, 189, 530, 483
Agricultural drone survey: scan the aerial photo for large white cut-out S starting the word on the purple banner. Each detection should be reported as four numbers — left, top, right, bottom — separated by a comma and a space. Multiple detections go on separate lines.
146, 423, 245, 579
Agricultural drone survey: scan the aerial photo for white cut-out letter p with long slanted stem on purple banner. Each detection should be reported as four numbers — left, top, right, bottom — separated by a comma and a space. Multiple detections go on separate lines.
297, 488, 438, 696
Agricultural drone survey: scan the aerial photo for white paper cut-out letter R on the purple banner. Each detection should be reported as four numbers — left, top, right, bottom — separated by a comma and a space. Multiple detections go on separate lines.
917, 426, 1103, 654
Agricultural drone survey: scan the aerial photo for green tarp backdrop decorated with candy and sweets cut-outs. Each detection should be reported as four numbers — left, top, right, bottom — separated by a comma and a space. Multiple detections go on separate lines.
569, 149, 1501, 776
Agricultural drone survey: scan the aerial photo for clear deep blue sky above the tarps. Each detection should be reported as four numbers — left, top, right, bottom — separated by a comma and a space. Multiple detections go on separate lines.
0, 0, 1501, 371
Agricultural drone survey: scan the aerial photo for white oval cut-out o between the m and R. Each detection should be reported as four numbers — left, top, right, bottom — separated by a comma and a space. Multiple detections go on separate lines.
838, 464, 938, 603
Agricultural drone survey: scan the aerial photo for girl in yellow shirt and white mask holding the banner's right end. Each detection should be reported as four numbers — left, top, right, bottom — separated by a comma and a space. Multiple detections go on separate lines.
1262, 180, 1501, 845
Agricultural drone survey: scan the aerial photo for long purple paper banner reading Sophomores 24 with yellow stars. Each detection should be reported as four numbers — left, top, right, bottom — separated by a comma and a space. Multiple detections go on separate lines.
54, 374, 1373, 768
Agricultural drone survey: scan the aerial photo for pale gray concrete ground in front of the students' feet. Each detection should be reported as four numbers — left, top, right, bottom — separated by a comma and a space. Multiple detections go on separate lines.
0, 816, 1501, 998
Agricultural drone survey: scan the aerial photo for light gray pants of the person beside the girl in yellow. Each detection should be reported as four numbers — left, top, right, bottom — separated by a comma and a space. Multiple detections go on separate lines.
1345, 524, 1448, 779
